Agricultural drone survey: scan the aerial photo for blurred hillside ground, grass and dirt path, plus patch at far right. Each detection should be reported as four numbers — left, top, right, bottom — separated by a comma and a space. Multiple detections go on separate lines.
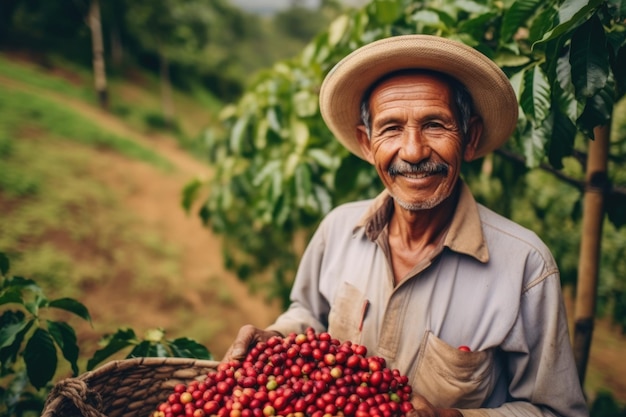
0, 51, 626, 402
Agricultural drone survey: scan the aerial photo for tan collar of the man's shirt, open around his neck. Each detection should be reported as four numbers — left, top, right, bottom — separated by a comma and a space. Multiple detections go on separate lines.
354, 181, 489, 263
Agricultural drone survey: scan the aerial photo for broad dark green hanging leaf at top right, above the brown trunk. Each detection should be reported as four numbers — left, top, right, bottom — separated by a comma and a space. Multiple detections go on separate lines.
570, 16, 609, 100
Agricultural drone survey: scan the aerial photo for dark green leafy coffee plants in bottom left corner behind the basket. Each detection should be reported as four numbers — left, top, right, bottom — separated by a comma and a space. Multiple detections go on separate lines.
0, 252, 212, 416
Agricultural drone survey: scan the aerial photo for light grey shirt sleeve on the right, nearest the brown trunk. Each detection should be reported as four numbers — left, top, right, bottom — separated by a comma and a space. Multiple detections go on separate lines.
460, 272, 589, 417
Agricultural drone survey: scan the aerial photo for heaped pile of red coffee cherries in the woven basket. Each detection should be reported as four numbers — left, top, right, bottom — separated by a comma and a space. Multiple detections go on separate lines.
151, 328, 413, 417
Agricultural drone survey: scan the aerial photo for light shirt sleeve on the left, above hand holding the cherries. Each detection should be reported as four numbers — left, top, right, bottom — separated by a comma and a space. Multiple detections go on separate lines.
267, 222, 330, 335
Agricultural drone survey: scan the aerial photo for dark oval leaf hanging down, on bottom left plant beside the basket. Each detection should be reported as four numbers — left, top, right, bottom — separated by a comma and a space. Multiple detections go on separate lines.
24, 328, 57, 389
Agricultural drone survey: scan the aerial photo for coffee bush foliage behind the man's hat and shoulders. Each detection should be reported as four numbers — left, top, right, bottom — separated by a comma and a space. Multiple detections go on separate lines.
189, 0, 626, 325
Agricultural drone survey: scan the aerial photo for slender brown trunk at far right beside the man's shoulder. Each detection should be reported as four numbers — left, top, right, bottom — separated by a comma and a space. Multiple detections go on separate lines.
574, 126, 610, 385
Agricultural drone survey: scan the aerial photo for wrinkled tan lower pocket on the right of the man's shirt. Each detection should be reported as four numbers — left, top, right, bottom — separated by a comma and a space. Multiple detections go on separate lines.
413, 331, 497, 408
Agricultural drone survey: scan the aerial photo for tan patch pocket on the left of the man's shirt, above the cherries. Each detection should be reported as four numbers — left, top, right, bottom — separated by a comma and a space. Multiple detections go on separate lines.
328, 282, 368, 343
